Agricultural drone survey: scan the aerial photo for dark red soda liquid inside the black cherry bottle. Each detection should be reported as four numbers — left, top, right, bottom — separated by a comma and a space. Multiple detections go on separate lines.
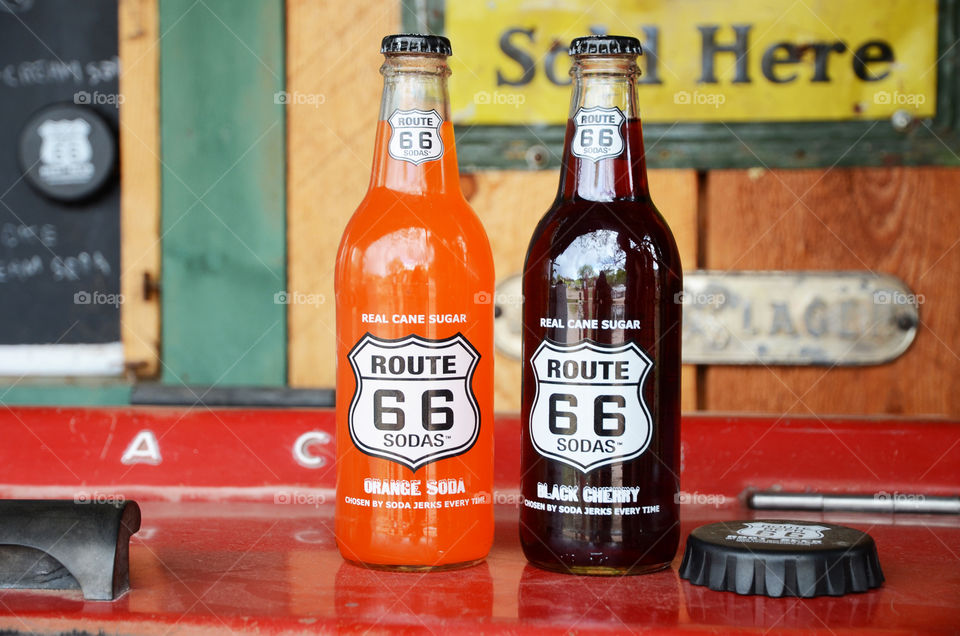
520, 119, 683, 574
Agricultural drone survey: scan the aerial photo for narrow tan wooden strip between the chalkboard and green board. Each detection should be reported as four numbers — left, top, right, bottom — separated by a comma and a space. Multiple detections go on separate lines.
118, 0, 160, 377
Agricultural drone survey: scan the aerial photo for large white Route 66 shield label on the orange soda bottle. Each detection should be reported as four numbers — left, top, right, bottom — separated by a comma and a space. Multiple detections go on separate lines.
347, 333, 480, 471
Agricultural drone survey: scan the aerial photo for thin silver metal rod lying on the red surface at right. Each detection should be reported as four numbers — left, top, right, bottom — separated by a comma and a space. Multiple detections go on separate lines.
747, 492, 960, 515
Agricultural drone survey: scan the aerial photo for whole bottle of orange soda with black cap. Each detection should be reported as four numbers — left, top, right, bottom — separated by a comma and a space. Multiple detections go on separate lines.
335, 35, 494, 570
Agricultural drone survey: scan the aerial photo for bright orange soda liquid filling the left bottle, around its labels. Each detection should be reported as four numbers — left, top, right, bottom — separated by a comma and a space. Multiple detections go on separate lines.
335, 121, 494, 569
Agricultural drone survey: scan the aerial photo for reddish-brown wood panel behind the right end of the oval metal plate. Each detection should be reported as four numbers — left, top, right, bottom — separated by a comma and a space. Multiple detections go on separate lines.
701, 168, 960, 417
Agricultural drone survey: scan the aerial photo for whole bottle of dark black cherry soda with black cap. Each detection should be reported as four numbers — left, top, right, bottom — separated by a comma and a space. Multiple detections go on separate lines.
520, 36, 683, 575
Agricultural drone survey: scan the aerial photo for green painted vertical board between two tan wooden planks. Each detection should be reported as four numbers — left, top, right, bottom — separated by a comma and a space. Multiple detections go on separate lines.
159, 0, 287, 386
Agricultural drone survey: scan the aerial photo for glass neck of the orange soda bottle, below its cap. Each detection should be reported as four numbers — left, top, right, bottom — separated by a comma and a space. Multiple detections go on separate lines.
370, 53, 460, 195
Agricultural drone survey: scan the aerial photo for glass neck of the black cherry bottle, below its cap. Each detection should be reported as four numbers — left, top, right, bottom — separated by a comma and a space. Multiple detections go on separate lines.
558, 55, 650, 201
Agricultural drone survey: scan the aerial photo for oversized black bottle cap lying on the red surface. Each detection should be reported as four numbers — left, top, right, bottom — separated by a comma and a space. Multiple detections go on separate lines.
680, 519, 883, 598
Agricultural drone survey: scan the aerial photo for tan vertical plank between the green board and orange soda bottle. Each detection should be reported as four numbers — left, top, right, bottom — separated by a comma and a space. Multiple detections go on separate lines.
287, 0, 400, 387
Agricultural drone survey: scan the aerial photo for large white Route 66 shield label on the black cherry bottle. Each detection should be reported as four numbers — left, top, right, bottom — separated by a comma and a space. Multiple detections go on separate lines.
530, 340, 653, 473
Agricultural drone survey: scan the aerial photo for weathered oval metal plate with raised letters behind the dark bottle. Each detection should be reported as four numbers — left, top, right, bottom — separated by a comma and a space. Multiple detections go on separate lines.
494, 270, 924, 366
